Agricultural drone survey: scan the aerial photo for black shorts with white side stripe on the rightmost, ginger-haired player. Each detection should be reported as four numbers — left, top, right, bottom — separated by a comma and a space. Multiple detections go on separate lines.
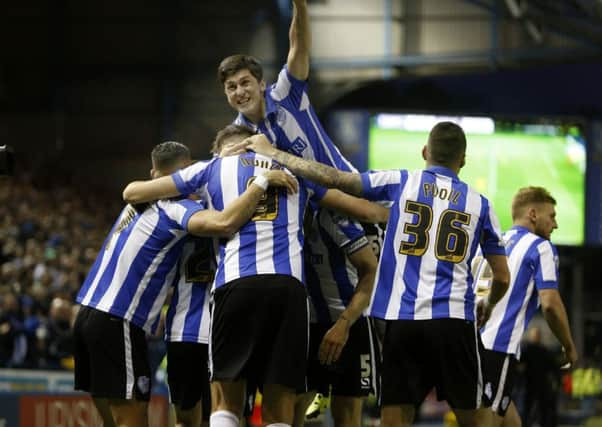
481, 348, 517, 417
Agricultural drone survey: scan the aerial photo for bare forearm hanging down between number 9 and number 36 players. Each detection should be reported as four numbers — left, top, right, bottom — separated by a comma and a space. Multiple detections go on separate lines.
318, 245, 377, 365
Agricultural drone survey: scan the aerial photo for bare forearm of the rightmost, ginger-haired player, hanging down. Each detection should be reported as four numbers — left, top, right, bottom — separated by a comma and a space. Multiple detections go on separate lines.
539, 289, 577, 365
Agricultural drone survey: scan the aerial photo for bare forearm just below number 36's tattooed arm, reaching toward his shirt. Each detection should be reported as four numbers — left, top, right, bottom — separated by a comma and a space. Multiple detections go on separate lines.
319, 189, 389, 224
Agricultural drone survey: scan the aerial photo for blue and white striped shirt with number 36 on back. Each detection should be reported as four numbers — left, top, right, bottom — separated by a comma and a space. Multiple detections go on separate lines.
361, 166, 504, 321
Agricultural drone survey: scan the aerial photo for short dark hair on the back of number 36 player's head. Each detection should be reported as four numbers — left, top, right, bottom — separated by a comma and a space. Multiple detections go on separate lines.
428, 122, 466, 167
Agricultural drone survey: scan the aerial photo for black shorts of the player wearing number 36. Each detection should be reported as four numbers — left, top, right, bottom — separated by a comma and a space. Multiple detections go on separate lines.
381, 319, 482, 409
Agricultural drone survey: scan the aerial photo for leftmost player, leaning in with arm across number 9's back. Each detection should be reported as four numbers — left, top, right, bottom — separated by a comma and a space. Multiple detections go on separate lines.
73, 142, 295, 426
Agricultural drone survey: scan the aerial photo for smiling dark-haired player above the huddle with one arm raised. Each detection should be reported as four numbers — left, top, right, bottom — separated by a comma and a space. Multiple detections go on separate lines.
217, 0, 355, 171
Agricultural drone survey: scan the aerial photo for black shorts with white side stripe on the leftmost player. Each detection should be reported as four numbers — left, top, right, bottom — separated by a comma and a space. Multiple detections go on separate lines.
73, 306, 151, 401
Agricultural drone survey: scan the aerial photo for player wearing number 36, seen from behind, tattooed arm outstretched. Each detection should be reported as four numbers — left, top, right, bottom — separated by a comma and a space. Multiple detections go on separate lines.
241, 122, 509, 427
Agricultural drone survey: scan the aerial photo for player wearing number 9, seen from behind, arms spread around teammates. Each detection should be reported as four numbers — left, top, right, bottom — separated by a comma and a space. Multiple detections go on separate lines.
124, 125, 388, 427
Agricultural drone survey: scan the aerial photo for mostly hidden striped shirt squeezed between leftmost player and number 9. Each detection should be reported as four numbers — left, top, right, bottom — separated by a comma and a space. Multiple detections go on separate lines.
165, 236, 215, 344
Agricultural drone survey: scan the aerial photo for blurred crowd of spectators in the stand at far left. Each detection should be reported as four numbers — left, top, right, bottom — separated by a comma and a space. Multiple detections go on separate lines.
0, 176, 121, 369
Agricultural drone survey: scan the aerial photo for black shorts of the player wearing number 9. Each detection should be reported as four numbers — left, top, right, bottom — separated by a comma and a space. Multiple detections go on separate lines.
209, 274, 309, 392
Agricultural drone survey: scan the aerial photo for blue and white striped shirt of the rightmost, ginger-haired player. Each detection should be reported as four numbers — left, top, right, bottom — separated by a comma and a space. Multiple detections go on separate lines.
474, 226, 558, 358
